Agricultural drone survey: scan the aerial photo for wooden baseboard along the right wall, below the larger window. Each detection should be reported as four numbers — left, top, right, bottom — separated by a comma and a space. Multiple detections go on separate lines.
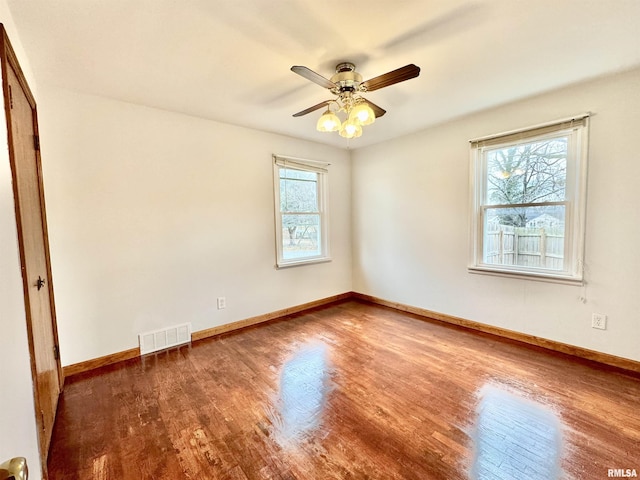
351, 292, 640, 374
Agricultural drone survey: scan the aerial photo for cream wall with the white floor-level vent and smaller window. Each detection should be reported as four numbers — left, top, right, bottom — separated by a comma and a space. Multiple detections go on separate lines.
40, 85, 351, 365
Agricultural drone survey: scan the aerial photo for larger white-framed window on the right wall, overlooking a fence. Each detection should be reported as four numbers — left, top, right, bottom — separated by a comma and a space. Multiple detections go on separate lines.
469, 114, 588, 283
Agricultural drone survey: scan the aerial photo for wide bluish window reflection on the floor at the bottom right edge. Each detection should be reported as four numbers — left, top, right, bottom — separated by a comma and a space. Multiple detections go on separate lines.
471, 385, 562, 480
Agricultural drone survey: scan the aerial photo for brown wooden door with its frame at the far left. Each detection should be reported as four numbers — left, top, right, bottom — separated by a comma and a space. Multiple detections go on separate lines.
0, 26, 62, 475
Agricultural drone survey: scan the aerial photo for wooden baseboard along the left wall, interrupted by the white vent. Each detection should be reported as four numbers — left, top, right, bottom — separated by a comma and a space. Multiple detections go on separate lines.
62, 292, 353, 379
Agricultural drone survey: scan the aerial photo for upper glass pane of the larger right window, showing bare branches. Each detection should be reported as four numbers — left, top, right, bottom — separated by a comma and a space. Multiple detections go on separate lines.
485, 136, 568, 205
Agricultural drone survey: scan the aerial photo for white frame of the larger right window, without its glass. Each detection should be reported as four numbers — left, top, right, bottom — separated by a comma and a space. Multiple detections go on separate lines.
468, 113, 589, 285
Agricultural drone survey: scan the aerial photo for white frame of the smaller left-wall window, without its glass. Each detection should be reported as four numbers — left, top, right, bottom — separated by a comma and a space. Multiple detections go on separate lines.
273, 155, 331, 268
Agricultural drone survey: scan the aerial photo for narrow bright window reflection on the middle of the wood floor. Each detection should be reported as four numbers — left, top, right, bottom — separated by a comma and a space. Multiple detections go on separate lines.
269, 342, 332, 447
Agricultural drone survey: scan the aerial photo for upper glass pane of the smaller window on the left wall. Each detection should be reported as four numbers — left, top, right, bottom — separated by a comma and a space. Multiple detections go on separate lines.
280, 169, 318, 212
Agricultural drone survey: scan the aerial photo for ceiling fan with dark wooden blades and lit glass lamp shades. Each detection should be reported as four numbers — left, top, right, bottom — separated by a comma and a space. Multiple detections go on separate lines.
291, 62, 420, 138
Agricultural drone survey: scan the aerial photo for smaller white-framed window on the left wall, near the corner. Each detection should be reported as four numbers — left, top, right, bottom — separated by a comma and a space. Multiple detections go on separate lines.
273, 155, 330, 268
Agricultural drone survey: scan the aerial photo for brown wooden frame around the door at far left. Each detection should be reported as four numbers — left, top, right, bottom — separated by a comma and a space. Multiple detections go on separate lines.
0, 23, 64, 478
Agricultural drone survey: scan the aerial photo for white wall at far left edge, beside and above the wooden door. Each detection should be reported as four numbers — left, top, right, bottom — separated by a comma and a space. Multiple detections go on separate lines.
0, 0, 41, 478
